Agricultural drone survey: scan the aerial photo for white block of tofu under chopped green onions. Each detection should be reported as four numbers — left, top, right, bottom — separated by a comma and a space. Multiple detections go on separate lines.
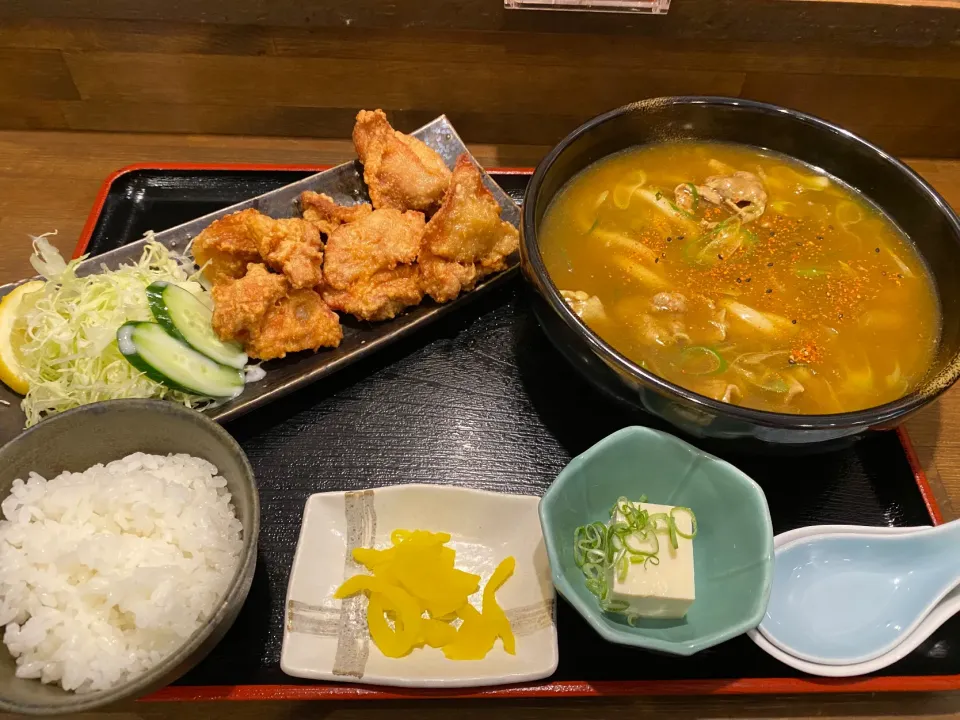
608, 503, 695, 619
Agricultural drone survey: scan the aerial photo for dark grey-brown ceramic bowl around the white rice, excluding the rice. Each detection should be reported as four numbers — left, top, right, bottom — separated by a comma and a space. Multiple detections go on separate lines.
0, 400, 260, 715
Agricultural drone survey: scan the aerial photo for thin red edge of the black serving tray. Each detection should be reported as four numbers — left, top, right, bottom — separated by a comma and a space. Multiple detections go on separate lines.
79, 162, 960, 702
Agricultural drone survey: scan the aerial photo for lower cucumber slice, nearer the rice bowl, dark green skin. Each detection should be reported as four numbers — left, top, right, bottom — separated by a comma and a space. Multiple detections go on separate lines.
117, 322, 243, 398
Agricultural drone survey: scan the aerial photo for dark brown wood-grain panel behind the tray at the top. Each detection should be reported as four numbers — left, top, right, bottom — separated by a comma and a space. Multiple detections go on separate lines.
0, 6, 960, 157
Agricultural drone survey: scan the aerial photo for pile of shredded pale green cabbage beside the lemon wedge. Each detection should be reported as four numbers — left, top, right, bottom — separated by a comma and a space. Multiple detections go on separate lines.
16, 234, 214, 427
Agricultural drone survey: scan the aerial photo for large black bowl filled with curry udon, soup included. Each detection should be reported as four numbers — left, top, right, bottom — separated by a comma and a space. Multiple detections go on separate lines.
521, 97, 960, 445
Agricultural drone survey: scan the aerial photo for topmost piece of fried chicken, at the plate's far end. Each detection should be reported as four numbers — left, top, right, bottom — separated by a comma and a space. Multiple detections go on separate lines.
353, 110, 450, 215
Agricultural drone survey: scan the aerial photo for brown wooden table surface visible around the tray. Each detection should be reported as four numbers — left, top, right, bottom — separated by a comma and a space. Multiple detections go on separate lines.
0, 132, 960, 720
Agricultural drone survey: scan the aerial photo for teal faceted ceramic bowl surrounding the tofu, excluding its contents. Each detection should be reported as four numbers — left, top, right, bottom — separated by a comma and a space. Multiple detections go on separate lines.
540, 427, 773, 655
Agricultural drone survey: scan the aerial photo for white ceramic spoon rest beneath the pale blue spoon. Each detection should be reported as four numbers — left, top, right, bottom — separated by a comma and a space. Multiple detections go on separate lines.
747, 525, 960, 677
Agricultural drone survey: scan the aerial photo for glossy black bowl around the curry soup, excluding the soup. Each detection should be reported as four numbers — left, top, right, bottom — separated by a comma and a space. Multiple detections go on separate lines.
520, 97, 960, 449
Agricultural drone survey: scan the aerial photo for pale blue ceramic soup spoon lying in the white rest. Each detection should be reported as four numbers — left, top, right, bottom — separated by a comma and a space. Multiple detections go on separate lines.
759, 522, 960, 665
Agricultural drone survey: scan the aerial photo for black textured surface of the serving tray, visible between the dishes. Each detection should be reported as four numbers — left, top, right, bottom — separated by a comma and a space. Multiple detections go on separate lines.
90, 166, 960, 685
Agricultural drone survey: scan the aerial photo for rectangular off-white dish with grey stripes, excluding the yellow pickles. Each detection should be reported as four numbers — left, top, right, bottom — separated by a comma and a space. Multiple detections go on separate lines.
280, 484, 558, 688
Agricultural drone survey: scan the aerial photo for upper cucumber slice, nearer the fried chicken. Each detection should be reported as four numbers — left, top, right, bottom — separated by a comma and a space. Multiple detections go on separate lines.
147, 280, 247, 370
